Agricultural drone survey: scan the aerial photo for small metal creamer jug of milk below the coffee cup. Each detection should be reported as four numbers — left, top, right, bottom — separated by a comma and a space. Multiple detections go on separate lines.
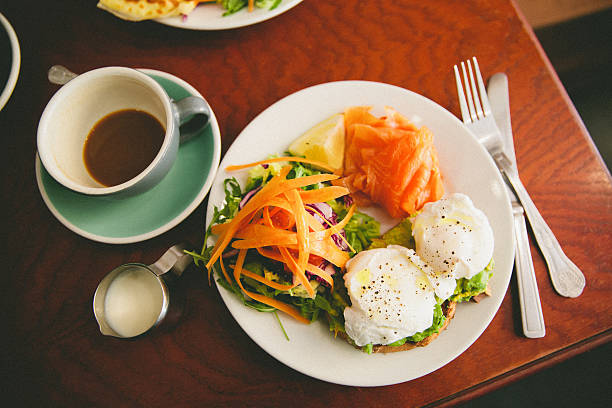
93, 244, 192, 338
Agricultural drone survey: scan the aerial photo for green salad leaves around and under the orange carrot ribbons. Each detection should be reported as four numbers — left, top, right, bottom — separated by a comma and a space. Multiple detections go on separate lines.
190, 162, 380, 335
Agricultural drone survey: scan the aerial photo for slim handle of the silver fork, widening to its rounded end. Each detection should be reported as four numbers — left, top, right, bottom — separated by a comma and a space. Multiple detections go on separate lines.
494, 153, 586, 297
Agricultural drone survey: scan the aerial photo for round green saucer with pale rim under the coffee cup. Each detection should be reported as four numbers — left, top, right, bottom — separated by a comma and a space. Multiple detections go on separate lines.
36, 69, 221, 244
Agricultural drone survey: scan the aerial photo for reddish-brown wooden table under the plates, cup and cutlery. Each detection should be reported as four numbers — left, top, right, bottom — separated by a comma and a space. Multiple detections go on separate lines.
0, 0, 612, 406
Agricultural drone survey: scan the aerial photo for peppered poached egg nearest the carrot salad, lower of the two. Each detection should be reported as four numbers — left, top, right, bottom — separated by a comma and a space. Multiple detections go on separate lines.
344, 245, 436, 346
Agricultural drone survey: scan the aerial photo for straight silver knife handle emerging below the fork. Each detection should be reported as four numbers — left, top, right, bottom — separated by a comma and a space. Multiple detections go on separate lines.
512, 203, 546, 338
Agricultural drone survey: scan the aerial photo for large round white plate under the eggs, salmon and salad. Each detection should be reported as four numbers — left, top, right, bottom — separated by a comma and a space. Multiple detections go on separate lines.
207, 81, 514, 386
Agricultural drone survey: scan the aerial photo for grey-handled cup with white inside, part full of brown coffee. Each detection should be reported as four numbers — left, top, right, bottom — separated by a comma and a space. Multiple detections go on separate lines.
37, 67, 211, 196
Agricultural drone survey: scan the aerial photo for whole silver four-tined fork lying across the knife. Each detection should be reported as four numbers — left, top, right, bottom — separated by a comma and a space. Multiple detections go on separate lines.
454, 57, 585, 297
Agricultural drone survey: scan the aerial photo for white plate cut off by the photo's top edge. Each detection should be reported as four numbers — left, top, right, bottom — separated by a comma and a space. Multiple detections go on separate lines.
155, 0, 302, 30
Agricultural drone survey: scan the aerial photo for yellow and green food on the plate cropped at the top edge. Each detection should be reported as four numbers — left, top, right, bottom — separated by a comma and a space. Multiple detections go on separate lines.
98, 0, 281, 21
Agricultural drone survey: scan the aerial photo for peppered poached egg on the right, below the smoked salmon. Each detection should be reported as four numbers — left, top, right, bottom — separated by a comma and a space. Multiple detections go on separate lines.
412, 193, 493, 299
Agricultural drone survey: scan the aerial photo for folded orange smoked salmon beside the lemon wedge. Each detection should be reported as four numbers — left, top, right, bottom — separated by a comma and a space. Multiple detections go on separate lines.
337, 106, 444, 218
